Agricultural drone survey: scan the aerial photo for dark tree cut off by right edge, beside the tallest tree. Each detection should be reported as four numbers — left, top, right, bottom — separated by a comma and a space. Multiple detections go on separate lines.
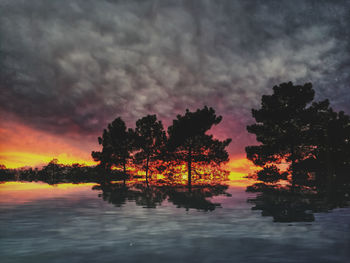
301, 100, 350, 190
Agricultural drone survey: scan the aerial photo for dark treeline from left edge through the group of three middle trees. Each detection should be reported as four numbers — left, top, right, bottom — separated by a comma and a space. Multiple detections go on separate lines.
0, 106, 231, 186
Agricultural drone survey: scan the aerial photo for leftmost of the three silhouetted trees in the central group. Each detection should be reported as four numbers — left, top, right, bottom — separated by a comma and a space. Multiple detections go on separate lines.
91, 117, 135, 182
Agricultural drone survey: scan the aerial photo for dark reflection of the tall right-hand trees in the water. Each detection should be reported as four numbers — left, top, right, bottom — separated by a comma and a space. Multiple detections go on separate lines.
247, 183, 350, 222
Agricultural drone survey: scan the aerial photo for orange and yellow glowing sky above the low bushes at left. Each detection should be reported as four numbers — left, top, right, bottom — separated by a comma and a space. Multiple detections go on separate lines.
0, 123, 96, 168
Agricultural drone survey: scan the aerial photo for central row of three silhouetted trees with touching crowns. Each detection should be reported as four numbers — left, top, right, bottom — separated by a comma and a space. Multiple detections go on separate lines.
92, 106, 231, 186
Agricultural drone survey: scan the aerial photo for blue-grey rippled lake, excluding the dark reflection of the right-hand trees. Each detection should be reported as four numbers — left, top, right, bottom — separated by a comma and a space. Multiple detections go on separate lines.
0, 181, 350, 263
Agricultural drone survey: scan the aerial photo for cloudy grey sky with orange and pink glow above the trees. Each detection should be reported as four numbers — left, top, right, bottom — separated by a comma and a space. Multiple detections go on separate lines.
0, 0, 350, 167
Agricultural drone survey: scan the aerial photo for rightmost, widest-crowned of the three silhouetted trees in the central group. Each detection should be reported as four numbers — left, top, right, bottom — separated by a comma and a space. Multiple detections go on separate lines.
168, 106, 231, 191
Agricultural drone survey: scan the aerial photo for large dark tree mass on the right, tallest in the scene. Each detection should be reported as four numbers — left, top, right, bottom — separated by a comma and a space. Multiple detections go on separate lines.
246, 82, 350, 190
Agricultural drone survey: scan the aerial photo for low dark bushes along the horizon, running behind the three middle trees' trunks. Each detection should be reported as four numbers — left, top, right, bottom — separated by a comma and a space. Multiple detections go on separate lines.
0, 159, 229, 187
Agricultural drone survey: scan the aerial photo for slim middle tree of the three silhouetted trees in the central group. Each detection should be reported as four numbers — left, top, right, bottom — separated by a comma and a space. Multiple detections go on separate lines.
134, 115, 166, 186
